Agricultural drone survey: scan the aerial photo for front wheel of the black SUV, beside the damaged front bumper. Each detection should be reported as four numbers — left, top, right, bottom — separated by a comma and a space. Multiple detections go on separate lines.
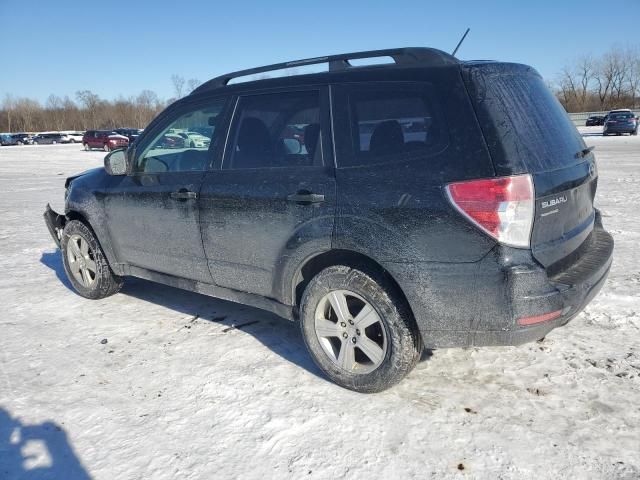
60, 220, 123, 300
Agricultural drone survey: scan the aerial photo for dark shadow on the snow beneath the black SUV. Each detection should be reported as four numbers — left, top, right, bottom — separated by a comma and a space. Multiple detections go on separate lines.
40, 250, 325, 379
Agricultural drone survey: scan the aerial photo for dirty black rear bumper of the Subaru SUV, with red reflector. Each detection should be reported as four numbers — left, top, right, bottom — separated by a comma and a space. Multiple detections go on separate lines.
385, 215, 613, 348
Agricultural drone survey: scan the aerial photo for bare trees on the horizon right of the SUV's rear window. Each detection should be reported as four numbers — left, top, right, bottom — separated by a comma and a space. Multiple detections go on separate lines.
552, 46, 640, 112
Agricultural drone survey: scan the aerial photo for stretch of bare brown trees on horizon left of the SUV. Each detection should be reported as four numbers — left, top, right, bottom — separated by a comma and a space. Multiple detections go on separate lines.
0, 75, 200, 132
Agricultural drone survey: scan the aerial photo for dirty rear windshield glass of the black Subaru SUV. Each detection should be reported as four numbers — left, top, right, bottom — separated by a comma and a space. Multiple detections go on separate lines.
465, 63, 585, 174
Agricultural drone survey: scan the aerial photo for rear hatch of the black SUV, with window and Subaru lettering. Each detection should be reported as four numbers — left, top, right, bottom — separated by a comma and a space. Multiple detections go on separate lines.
462, 62, 597, 273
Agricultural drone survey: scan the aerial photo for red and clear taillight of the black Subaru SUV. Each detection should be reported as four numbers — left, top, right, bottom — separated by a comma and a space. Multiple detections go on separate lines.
446, 174, 535, 248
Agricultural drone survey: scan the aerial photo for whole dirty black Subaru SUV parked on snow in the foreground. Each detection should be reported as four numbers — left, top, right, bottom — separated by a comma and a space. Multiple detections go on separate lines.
45, 48, 613, 392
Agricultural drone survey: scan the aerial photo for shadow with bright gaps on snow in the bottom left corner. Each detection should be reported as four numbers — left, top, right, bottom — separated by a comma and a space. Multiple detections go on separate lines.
0, 407, 91, 480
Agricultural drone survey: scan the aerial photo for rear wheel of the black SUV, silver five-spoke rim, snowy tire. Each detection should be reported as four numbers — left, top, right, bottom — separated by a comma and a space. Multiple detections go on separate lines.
300, 265, 422, 393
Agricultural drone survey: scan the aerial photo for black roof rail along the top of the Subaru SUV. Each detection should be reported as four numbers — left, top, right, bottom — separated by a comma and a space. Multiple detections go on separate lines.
193, 47, 459, 93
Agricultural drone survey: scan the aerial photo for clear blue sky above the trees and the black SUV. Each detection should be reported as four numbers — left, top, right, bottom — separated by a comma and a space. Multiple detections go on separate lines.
0, 0, 640, 101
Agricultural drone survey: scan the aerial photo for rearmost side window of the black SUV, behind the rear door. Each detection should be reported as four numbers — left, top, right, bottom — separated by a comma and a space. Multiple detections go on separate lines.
340, 84, 447, 167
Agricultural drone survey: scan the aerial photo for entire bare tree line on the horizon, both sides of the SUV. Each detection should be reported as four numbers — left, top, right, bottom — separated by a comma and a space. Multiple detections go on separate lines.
0, 47, 640, 132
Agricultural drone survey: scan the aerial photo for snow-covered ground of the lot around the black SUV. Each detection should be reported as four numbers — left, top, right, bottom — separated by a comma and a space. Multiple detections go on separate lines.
0, 127, 640, 480
